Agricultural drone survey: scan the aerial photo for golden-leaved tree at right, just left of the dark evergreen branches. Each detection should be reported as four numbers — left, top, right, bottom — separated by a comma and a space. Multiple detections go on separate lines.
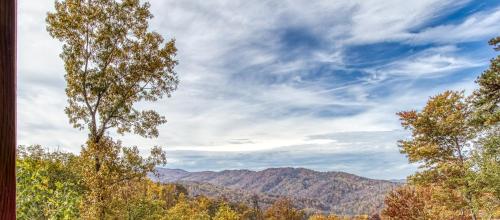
398, 91, 477, 217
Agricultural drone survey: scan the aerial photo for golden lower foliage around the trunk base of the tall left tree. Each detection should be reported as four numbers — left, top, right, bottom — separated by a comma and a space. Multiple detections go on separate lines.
79, 137, 166, 219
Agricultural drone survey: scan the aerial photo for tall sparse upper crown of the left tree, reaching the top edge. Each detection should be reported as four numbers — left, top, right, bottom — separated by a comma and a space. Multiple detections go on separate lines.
46, 0, 178, 141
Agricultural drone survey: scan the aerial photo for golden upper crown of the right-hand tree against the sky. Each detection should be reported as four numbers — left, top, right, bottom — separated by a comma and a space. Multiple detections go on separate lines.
398, 91, 472, 167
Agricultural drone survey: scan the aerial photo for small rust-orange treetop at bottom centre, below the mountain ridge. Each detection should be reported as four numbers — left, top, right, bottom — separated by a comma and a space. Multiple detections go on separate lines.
264, 199, 305, 220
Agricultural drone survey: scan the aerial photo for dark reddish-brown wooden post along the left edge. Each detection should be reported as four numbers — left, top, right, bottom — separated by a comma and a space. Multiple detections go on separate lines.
0, 0, 16, 220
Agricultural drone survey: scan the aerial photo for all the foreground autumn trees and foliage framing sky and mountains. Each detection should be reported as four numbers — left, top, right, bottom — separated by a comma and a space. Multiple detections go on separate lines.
12, 0, 500, 217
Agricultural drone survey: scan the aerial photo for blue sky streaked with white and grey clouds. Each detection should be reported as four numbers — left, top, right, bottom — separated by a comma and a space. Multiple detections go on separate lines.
17, 0, 500, 179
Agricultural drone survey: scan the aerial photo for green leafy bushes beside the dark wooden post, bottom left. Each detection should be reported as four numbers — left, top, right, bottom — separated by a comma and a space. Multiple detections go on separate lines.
16, 145, 85, 219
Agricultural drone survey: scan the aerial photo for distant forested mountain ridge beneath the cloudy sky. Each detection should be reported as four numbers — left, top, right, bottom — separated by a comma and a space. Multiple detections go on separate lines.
156, 167, 401, 215
